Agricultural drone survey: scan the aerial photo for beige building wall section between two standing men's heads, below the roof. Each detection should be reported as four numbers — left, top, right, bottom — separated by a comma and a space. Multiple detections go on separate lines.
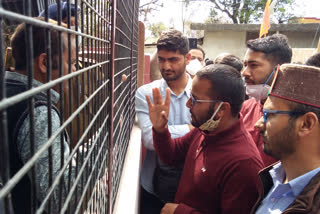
202, 31, 246, 59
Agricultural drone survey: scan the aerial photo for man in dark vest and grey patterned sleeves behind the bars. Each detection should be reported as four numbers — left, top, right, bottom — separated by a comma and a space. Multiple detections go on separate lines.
5, 18, 76, 214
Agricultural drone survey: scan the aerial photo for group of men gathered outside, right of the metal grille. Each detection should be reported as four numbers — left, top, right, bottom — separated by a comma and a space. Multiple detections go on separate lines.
136, 29, 320, 214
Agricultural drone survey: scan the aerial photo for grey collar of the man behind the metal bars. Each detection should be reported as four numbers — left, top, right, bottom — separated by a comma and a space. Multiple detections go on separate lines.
5, 71, 59, 104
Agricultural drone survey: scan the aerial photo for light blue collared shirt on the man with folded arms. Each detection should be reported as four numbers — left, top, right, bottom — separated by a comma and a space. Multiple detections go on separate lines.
135, 75, 192, 194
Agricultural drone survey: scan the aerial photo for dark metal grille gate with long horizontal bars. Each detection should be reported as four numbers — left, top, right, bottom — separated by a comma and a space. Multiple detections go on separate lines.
0, 0, 139, 214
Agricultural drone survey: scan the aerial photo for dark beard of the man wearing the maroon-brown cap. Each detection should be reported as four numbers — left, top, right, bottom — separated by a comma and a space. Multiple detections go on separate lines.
262, 119, 296, 160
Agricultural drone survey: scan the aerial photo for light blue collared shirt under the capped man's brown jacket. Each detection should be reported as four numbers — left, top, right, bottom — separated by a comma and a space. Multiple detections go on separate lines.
256, 162, 320, 214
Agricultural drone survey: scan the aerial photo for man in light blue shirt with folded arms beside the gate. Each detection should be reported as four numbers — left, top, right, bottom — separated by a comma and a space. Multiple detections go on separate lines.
135, 30, 193, 214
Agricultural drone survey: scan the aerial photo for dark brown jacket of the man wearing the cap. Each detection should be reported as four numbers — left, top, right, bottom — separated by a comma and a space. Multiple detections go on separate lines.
251, 165, 320, 214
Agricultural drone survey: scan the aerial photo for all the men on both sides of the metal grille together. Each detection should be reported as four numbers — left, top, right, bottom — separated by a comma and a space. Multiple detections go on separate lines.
1, 2, 320, 214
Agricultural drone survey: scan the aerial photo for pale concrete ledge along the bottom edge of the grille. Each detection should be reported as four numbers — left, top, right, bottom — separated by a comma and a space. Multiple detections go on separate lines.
113, 124, 141, 214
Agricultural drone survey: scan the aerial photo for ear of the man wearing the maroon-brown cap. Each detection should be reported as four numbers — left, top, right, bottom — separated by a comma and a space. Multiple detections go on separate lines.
296, 112, 319, 137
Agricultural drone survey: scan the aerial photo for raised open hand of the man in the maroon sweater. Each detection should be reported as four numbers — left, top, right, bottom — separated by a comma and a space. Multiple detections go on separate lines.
146, 88, 171, 132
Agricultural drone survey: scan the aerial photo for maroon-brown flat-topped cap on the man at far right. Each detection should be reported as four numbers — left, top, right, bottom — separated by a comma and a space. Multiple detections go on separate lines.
269, 64, 320, 108
